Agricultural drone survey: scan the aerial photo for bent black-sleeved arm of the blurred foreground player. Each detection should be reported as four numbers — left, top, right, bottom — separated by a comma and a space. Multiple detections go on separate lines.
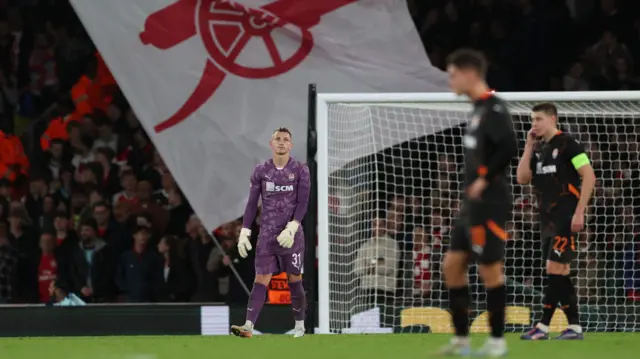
478, 105, 518, 180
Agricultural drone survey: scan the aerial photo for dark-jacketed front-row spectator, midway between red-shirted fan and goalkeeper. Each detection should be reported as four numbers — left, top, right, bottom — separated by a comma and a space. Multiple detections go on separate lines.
116, 226, 164, 303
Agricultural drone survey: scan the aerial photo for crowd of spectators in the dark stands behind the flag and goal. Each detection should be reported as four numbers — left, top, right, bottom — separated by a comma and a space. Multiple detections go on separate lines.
0, 0, 640, 310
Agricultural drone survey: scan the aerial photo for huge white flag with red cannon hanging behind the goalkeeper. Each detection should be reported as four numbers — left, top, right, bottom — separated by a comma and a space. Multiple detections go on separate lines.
71, 0, 446, 229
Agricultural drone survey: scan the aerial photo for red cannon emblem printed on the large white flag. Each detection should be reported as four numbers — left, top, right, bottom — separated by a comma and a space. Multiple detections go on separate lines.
140, 0, 356, 132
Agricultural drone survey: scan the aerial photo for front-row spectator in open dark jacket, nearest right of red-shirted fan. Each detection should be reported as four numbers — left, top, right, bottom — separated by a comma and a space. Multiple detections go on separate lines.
69, 218, 117, 302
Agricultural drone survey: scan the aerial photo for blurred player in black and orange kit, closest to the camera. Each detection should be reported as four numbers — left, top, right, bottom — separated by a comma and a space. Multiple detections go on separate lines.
440, 50, 518, 357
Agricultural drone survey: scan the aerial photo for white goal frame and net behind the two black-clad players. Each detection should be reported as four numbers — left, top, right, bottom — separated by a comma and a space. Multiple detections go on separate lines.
317, 92, 640, 333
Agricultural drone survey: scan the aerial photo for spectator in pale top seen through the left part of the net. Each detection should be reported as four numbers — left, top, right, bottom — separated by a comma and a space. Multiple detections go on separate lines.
353, 216, 400, 303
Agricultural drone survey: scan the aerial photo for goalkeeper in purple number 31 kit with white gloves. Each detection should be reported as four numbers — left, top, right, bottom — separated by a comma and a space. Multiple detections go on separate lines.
231, 128, 310, 338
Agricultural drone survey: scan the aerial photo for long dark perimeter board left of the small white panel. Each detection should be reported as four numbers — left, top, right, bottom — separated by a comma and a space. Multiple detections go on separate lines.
0, 305, 201, 337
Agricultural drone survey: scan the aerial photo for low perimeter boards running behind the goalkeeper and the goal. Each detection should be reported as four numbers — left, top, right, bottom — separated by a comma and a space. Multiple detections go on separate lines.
0, 302, 640, 337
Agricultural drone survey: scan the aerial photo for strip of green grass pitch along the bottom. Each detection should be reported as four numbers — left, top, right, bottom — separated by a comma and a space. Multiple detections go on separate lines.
0, 333, 640, 359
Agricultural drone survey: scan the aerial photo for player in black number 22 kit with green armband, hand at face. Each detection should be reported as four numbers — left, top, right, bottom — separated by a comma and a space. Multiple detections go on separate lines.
517, 103, 596, 340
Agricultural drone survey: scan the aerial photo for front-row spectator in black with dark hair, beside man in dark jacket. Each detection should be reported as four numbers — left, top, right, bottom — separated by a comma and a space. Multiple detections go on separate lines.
158, 235, 195, 302
